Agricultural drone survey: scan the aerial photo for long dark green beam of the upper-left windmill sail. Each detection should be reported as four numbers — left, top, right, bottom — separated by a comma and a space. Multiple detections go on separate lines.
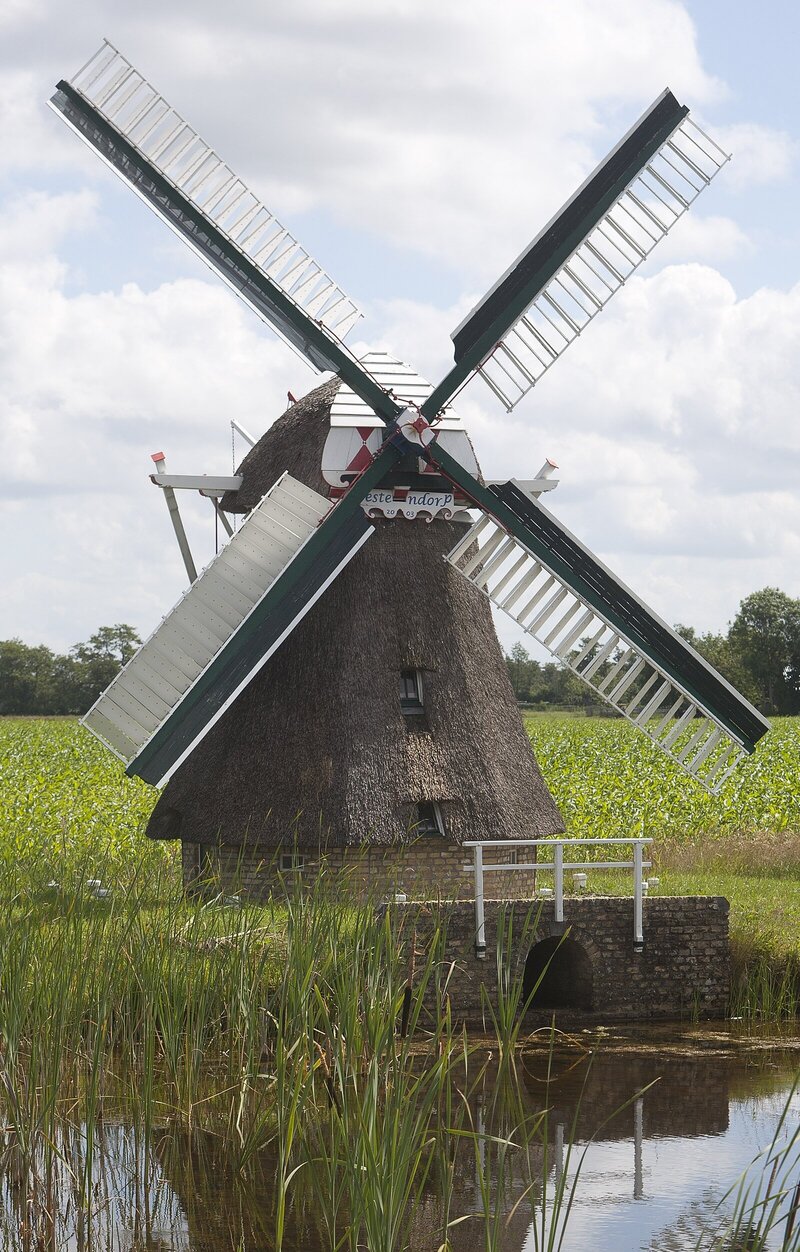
56, 81, 402, 422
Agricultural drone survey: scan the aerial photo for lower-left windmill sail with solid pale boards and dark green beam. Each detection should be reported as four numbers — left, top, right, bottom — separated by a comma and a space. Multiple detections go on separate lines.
83, 475, 373, 786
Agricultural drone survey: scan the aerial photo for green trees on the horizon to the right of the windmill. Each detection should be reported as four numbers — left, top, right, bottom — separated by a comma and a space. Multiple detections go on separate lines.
506, 587, 800, 716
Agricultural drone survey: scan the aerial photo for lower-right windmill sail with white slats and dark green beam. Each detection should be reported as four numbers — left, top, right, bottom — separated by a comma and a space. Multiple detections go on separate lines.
434, 449, 769, 793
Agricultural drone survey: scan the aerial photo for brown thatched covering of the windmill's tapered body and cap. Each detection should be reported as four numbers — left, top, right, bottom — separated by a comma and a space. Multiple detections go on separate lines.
148, 379, 563, 849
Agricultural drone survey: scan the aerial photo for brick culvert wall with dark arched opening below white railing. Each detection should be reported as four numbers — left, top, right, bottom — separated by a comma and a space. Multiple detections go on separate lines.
391, 896, 730, 1028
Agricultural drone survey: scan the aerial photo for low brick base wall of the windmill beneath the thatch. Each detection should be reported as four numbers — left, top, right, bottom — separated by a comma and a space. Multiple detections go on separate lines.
183, 836, 536, 900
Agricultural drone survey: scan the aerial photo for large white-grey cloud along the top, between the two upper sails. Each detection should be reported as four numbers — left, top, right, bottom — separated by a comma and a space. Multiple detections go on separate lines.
0, 0, 725, 283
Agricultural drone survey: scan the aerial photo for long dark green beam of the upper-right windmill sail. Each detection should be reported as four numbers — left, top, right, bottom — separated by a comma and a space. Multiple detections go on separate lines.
421, 105, 689, 422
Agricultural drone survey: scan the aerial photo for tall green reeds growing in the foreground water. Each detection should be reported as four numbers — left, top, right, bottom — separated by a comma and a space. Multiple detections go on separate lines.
0, 870, 795, 1252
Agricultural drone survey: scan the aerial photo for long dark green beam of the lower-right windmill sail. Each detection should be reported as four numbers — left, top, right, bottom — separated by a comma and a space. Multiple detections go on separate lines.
431, 441, 769, 754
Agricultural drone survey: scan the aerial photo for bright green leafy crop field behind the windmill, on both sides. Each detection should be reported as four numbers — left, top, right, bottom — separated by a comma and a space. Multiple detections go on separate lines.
0, 715, 800, 879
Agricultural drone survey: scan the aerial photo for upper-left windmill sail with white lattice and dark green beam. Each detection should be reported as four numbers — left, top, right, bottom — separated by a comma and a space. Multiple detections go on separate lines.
50, 41, 394, 417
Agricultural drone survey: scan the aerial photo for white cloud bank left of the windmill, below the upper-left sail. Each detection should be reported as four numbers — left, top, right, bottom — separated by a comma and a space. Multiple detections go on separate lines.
0, 187, 319, 647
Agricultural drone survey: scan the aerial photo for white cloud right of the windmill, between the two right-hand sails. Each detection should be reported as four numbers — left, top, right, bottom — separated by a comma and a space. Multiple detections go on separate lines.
373, 264, 800, 629
